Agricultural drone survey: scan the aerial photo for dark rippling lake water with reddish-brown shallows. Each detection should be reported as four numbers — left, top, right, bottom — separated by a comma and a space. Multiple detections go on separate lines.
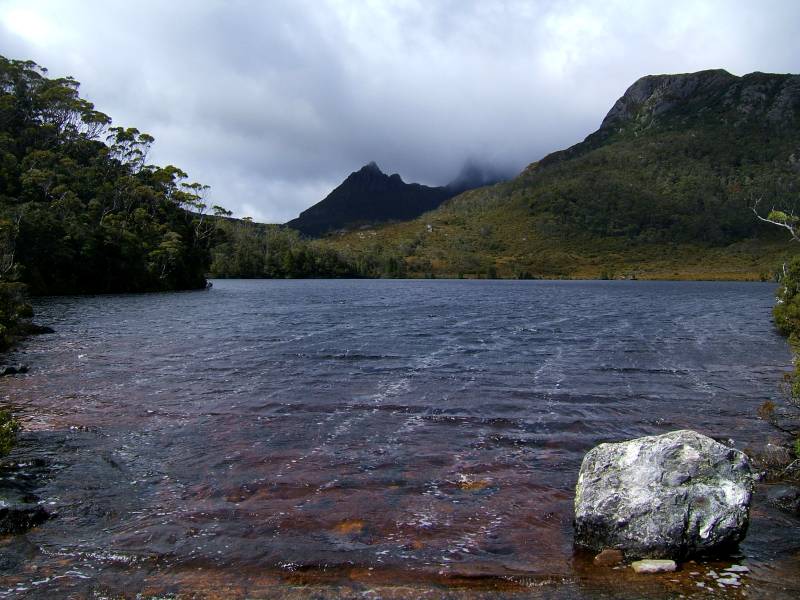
0, 281, 800, 598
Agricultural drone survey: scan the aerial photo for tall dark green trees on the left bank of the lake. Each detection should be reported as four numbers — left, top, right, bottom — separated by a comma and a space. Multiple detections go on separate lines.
0, 57, 219, 294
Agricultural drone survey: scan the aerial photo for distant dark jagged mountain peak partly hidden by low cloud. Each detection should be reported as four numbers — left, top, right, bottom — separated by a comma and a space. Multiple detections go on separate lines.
286, 162, 510, 236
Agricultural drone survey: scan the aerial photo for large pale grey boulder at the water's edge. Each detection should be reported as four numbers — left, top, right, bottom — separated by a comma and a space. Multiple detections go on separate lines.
575, 430, 753, 559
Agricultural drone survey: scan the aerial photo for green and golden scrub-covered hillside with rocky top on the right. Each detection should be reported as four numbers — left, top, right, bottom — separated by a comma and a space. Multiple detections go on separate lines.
324, 70, 800, 279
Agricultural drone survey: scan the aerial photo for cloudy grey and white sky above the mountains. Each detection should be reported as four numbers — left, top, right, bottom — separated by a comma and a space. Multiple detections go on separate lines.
0, 0, 800, 223
